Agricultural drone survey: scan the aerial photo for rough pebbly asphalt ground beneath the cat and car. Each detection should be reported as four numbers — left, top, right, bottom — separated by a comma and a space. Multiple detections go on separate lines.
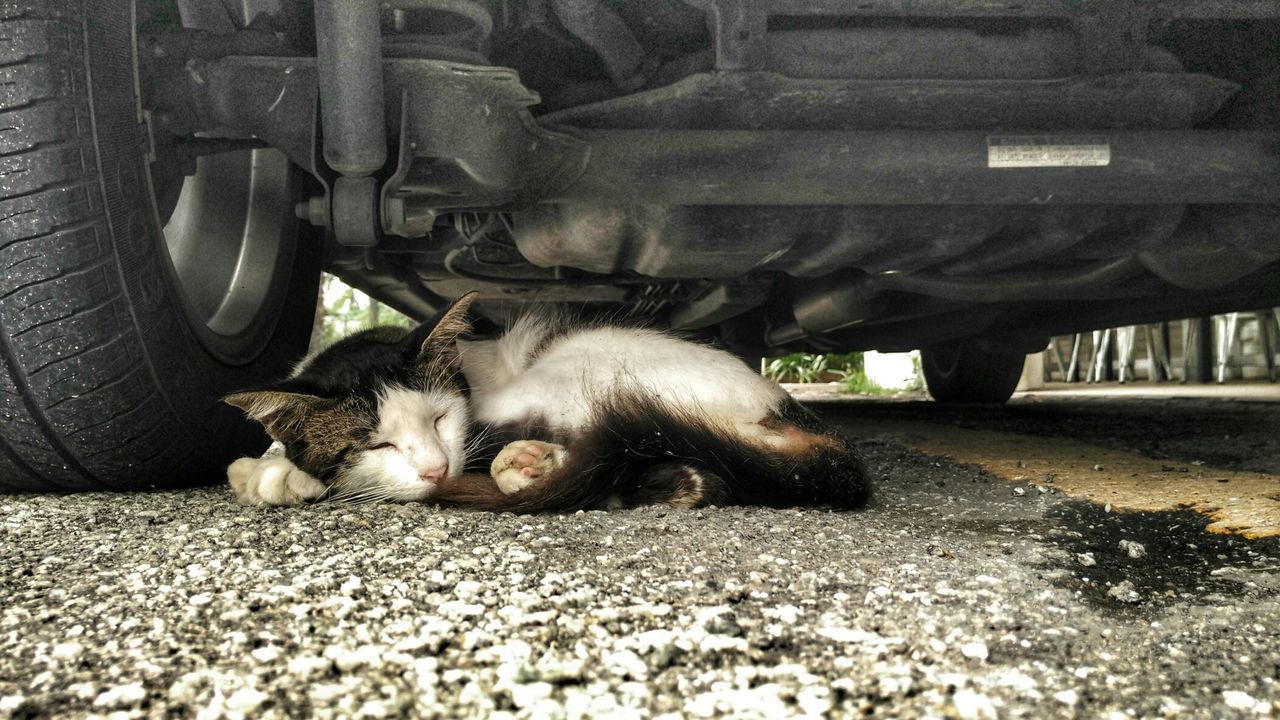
0, 389, 1280, 717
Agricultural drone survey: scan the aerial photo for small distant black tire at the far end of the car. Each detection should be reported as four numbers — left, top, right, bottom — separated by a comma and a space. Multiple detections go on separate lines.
920, 340, 1027, 404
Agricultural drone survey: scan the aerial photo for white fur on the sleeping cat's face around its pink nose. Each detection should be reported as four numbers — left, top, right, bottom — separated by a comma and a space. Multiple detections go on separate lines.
334, 388, 470, 501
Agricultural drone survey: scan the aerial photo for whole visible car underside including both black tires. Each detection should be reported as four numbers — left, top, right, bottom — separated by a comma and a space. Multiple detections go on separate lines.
0, 0, 1280, 489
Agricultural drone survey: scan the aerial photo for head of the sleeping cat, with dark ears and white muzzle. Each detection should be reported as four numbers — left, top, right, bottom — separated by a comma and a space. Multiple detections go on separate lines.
225, 292, 471, 501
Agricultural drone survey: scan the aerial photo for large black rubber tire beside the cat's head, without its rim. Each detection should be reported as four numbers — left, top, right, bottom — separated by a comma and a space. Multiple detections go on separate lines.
0, 0, 319, 491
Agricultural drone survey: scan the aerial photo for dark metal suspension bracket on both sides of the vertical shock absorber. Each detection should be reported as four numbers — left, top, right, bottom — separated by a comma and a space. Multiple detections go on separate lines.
144, 56, 589, 233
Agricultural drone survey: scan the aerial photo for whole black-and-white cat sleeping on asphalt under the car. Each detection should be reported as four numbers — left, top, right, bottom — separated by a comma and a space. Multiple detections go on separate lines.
225, 293, 868, 512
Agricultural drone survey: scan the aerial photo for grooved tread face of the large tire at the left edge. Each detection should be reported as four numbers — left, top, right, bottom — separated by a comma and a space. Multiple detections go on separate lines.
0, 3, 178, 491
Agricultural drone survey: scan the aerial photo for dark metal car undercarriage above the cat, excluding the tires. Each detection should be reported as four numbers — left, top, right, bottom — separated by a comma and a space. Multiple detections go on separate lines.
141, 0, 1280, 355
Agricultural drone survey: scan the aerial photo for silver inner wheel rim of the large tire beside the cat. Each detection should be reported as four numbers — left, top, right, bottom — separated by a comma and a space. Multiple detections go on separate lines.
164, 150, 297, 365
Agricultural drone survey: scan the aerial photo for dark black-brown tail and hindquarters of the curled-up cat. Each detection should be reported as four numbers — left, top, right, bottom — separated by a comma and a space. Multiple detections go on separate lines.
436, 395, 869, 512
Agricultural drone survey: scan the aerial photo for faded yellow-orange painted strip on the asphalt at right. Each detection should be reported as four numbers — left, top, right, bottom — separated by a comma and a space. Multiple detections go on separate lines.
841, 420, 1280, 539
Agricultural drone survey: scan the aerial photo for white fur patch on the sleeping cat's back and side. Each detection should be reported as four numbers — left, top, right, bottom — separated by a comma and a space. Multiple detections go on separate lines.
462, 322, 786, 434
